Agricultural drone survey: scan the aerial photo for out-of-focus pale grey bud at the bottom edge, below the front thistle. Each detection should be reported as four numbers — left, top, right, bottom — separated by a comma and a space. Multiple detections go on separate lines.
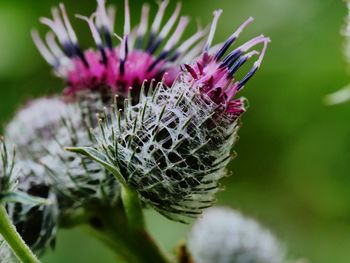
188, 208, 286, 263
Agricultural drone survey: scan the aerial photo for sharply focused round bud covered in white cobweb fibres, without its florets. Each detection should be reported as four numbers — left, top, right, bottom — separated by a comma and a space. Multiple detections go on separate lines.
97, 78, 239, 221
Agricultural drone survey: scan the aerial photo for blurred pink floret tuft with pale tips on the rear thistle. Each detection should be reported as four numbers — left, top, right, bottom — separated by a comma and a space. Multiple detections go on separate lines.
32, 0, 204, 101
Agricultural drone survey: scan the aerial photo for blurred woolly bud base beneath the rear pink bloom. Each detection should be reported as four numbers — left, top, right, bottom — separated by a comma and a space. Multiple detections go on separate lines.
39, 95, 120, 213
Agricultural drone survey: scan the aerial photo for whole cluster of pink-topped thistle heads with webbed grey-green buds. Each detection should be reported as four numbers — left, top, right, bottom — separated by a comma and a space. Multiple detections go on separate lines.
2, 0, 270, 260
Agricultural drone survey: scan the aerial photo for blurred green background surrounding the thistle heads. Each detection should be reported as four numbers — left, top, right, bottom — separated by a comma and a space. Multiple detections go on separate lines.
0, 0, 350, 263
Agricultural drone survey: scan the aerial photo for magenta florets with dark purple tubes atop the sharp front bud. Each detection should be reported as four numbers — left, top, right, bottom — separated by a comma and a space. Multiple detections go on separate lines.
184, 10, 270, 117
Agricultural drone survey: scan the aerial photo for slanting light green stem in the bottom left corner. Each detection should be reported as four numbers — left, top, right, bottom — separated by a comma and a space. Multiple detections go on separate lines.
0, 204, 40, 263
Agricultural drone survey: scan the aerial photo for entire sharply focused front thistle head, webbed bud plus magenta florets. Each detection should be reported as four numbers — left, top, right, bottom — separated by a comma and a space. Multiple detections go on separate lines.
70, 9, 269, 222
